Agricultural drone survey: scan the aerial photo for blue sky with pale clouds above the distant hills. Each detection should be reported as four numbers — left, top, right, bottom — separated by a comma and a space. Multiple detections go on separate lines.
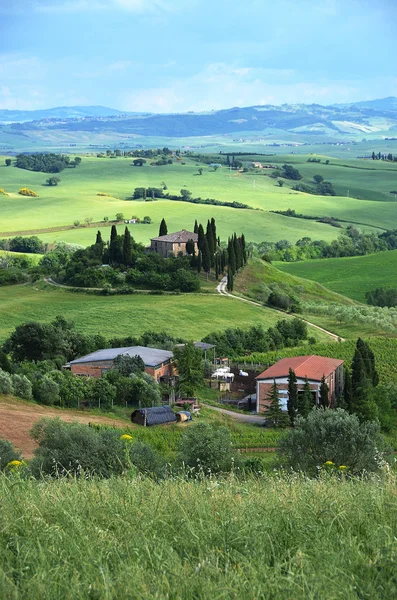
0, 0, 397, 112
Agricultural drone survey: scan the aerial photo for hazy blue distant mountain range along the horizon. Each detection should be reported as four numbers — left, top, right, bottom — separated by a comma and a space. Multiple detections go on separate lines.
0, 97, 397, 150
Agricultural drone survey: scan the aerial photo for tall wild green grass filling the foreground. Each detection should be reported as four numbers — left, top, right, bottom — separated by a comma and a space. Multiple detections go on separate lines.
0, 475, 397, 600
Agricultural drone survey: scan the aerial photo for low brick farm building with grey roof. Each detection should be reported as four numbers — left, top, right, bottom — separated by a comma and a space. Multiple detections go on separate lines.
66, 346, 176, 381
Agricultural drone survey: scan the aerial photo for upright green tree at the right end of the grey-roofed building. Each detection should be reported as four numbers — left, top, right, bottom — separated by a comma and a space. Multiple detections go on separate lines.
174, 342, 204, 397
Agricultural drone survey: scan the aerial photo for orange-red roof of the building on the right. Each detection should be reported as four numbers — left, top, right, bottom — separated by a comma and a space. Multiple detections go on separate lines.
257, 354, 344, 381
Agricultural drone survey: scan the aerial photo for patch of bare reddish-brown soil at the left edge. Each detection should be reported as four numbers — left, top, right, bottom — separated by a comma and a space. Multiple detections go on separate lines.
0, 396, 128, 458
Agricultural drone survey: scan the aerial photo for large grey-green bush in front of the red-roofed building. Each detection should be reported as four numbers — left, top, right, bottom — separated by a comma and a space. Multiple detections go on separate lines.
279, 408, 385, 475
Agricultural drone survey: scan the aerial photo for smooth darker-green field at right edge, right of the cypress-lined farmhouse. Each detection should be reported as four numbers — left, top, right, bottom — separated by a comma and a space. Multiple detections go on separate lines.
276, 250, 397, 302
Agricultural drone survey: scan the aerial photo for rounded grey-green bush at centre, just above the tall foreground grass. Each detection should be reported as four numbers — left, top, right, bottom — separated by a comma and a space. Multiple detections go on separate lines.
176, 423, 240, 475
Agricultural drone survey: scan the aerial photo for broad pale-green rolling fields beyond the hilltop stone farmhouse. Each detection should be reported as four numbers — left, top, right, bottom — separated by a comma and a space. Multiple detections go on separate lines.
0, 155, 397, 250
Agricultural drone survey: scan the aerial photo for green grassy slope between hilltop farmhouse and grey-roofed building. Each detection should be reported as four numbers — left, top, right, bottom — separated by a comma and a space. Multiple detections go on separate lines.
0, 283, 298, 340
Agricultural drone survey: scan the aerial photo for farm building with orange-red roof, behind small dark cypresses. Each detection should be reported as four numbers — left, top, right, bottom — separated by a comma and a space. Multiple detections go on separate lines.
256, 354, 343, 413
